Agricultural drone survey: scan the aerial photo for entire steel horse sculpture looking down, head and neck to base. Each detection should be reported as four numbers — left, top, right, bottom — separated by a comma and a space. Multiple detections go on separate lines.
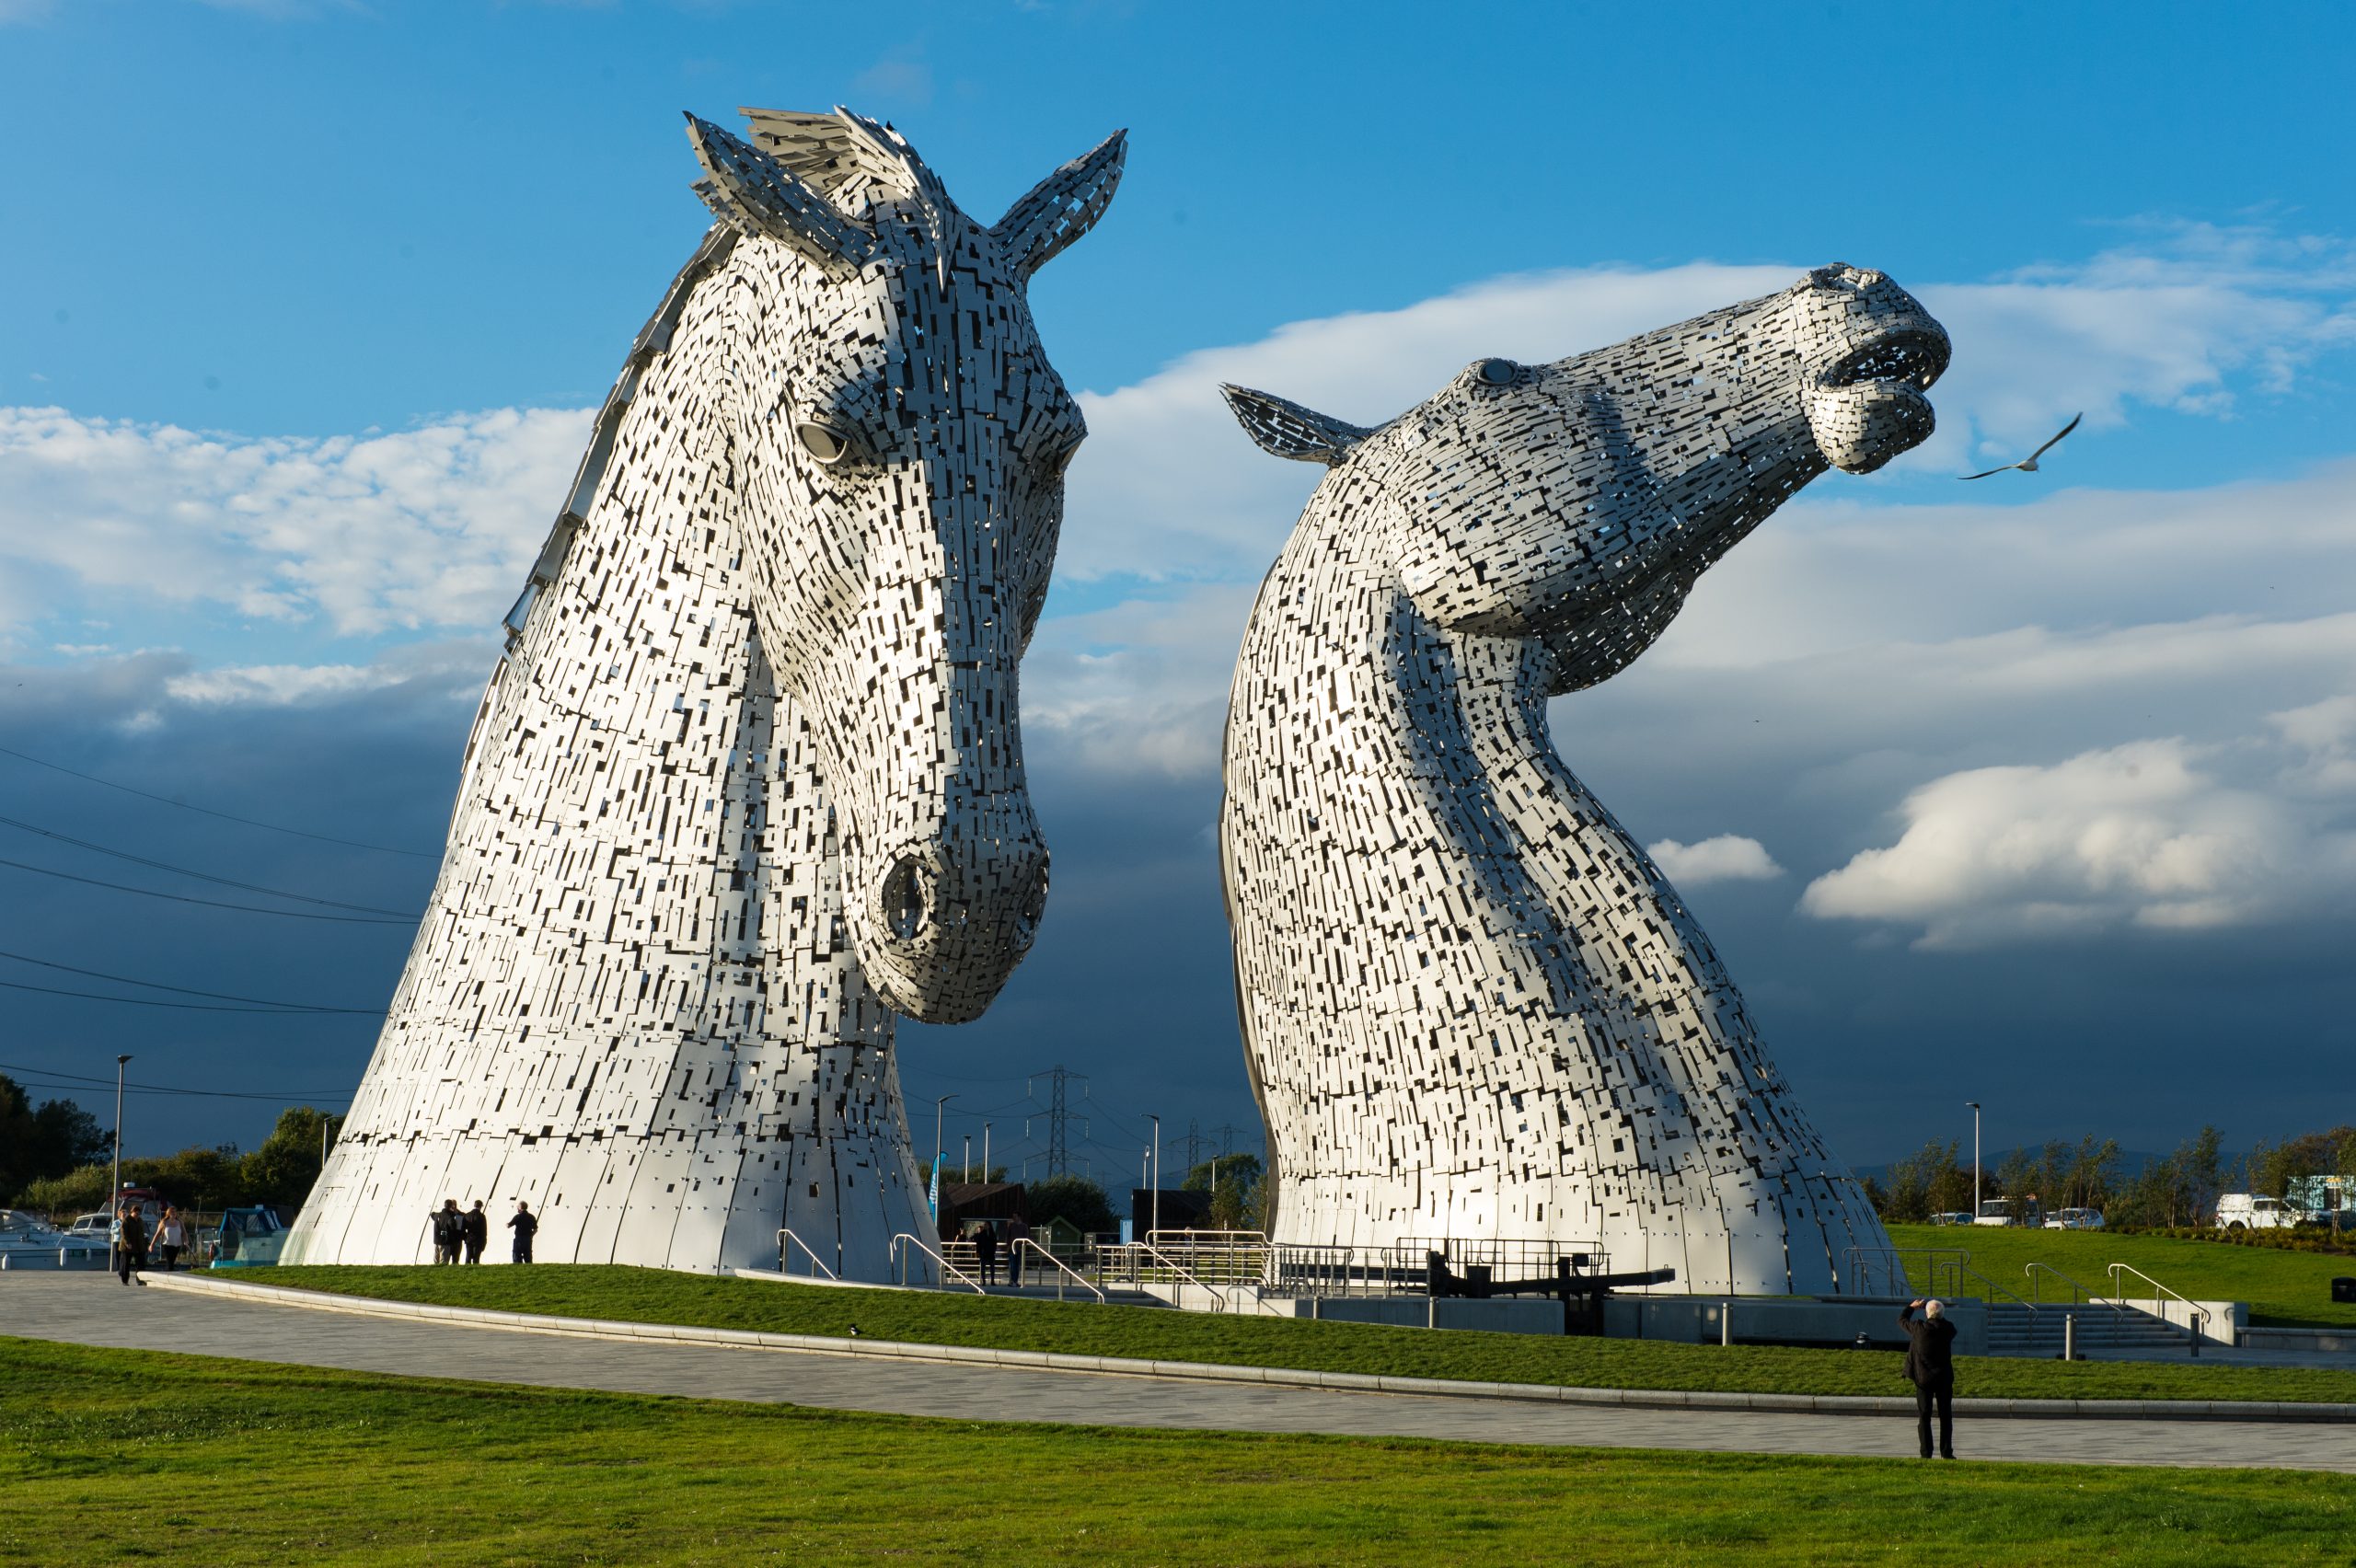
287, 110, 1122, 1278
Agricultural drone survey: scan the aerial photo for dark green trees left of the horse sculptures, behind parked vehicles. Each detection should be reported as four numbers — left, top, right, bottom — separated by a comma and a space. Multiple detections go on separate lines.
0, 1074, 344, 1217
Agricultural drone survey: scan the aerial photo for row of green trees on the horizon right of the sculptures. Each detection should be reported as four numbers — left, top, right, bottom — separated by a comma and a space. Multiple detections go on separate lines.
1866, 1125, 2356, 1229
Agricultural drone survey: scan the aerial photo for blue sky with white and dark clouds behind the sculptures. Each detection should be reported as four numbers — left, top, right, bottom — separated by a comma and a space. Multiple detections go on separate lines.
0, 0, 2356, 1175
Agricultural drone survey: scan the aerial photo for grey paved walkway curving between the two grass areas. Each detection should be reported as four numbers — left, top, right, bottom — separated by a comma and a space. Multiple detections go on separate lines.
0, 1272, 2356, 1474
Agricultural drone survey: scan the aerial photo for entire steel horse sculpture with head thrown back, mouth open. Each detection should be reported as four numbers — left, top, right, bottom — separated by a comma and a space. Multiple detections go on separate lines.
1220, 266, 1948, 1293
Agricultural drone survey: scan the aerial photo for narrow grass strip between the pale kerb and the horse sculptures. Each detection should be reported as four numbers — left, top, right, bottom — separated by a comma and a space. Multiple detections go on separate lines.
249, 1264, 2356, 1403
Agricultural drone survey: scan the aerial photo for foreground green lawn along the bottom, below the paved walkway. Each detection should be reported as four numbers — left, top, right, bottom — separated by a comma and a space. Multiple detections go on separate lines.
0, 1340, 2356, 1568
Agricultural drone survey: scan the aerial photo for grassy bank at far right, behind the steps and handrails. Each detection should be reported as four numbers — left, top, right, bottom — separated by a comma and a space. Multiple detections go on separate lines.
1889, 1224, 2356, 1328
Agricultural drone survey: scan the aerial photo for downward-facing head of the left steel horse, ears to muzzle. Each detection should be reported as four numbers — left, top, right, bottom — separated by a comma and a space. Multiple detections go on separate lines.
688, 110, 1124, 1021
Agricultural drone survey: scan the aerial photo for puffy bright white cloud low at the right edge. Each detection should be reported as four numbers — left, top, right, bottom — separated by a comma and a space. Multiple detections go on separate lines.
1800, 739, 2356, 949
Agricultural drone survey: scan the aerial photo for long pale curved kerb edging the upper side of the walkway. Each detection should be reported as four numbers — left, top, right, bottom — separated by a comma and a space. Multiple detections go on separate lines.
146, 1274, 2356, 1424
